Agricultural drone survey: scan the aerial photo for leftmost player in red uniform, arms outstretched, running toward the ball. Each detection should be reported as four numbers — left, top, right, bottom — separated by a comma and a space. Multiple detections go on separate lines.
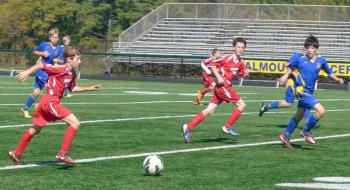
9, 48, 101, 165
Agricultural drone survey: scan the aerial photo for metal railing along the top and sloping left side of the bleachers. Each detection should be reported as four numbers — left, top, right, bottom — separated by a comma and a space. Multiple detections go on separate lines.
118, 3, 350, 48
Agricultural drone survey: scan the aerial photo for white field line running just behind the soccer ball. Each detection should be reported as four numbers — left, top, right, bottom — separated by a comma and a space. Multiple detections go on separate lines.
0, 133, 350, 171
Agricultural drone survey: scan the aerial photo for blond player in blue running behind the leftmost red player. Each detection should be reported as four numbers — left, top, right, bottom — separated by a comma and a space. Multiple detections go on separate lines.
20, 28, 64, 118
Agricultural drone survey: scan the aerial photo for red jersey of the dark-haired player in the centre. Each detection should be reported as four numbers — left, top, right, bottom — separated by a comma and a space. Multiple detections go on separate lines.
208, 55, 247, 86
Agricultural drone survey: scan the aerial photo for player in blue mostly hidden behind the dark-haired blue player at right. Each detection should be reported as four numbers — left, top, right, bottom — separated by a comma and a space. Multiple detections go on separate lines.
259, 48, 311, 122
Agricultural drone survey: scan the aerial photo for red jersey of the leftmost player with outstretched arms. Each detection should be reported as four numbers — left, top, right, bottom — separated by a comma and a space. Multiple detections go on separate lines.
41, 64, 77, 100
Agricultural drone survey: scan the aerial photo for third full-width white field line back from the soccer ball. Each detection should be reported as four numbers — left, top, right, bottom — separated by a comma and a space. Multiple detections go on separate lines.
0, 98, 350, 106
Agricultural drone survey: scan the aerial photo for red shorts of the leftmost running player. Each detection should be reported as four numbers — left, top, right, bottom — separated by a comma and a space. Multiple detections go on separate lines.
32, 96, 72, 127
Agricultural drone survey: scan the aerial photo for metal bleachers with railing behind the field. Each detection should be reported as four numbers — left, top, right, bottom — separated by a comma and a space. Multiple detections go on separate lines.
111, 3, 350, 67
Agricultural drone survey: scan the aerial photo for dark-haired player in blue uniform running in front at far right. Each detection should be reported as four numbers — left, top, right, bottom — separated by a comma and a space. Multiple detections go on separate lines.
279, 35, 344, 148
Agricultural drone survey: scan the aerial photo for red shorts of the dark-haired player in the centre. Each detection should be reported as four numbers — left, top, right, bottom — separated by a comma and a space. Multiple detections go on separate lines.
210, 86, 241, 104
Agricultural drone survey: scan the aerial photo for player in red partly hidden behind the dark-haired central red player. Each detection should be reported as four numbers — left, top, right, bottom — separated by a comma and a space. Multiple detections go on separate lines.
192, 48, 221, 105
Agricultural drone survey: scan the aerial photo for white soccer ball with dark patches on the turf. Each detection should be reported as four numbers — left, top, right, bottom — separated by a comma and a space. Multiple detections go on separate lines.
143, 155, 164, 175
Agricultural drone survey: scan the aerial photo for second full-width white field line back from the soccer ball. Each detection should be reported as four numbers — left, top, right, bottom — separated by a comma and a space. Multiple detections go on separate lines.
0, 109, 350, 129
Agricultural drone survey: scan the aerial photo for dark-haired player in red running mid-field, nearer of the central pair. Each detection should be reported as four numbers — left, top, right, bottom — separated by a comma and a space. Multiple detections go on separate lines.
182, 37, 248, 143
